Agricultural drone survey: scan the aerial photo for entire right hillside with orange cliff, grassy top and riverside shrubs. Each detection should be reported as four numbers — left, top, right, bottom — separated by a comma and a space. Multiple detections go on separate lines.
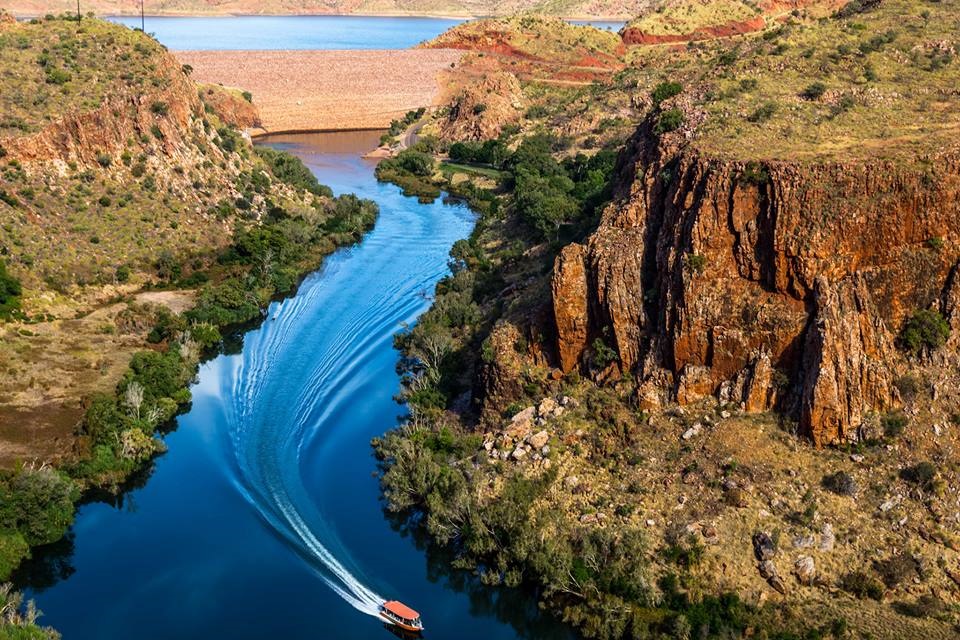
374, 0, 960, 640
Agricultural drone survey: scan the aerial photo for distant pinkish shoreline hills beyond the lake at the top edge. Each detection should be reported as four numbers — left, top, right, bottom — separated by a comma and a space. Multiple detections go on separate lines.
5, 0, 650, 20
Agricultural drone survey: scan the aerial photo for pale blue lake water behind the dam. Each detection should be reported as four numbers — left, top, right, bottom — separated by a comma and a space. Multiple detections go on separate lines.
110, 16, 623, 51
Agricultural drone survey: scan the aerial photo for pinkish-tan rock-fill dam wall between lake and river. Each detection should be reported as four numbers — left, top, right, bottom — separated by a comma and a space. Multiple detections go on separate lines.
177, 49, 463, 133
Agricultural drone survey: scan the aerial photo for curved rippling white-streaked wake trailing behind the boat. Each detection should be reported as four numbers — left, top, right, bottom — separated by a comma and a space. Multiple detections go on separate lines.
212, 171, 466, 616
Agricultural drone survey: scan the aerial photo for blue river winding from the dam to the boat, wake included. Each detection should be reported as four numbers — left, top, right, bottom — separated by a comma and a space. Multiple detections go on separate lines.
22, 132, 569, 640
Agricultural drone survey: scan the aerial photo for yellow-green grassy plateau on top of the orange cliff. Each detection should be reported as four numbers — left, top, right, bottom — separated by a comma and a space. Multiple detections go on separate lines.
629, 0, 960, 160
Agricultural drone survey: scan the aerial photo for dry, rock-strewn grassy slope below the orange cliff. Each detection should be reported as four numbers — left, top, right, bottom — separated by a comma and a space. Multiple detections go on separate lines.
510, 382, 960, 640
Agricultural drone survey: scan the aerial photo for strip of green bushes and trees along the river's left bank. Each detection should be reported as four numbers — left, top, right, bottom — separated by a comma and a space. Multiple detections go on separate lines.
0, 135, 378, 579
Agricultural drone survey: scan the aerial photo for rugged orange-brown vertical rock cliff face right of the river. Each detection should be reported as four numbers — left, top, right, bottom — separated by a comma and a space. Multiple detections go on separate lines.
553, 116, 960, 445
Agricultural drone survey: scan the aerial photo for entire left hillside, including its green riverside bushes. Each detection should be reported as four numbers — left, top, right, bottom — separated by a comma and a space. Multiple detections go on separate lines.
0, 14, 377, 584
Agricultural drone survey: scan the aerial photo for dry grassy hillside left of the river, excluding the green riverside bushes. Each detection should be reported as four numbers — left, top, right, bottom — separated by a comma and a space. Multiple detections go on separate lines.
0, 13, 334, 466
